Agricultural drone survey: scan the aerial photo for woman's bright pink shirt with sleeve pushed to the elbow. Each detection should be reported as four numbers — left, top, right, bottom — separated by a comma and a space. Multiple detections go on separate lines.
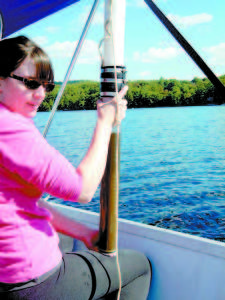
0, 104, 82, 283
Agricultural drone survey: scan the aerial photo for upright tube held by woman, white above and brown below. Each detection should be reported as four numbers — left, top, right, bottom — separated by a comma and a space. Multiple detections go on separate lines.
98, 0, 126, 255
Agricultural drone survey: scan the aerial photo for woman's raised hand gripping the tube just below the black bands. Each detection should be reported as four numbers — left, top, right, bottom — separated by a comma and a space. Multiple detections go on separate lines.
97, 86, 128, 126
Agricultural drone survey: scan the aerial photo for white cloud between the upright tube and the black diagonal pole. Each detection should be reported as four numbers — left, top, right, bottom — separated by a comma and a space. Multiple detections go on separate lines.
134, 47, 181, 63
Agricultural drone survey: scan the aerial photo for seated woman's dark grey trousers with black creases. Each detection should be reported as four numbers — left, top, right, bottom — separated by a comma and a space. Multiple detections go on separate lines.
0, 238, 151, 300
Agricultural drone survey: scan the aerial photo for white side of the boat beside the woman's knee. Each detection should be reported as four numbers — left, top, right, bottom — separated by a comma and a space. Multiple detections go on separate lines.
55, 205, 225, 300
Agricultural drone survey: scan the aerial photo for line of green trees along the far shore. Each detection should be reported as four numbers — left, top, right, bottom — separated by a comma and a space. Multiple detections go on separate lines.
39, 75, 225, 111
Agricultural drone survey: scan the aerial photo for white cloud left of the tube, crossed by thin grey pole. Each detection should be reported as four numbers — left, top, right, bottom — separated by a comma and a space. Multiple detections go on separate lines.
45, 40, 99, 64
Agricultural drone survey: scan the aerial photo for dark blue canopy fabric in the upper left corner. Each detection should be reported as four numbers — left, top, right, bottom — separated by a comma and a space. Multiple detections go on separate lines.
0, 0, 79, 38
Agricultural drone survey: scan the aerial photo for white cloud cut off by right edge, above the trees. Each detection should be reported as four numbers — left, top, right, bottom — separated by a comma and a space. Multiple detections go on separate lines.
204, 43, 225, 66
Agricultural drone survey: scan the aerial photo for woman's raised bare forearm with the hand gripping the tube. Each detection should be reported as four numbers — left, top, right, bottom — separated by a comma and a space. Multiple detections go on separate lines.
77, 86, 128, 203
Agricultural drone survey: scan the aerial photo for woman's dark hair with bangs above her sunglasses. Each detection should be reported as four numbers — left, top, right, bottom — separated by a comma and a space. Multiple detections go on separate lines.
0, 36, 54, 82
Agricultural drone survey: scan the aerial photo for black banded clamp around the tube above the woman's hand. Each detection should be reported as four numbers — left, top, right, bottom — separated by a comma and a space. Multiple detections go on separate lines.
100, 66, 127, 98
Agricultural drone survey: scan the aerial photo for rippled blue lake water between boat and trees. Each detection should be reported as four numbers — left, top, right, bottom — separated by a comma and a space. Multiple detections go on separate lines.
35, 106, 225, 241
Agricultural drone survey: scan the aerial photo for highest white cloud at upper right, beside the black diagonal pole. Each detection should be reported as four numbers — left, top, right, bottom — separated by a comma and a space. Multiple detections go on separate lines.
168, 13, 213, 27
